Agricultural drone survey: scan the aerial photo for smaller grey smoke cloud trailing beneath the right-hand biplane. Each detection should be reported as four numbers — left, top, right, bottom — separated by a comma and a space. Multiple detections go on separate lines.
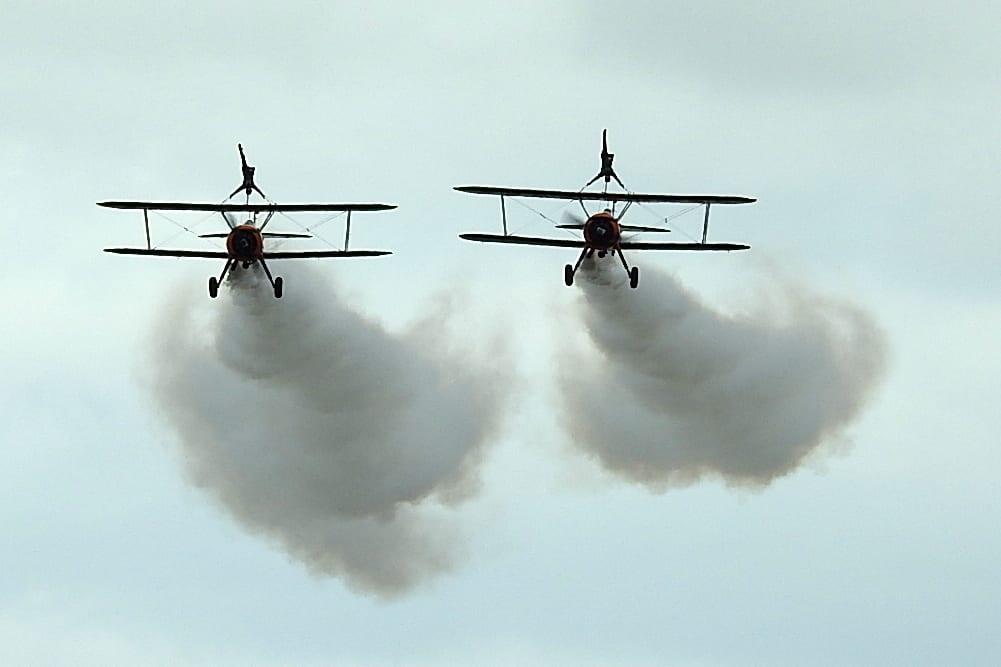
561, 260, 885, 490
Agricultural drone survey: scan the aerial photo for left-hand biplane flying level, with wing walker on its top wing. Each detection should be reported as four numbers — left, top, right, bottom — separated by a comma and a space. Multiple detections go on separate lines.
97, 146, 395, 298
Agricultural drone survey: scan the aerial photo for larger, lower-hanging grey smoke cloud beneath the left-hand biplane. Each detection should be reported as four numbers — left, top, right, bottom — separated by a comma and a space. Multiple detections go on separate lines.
151, 264, 506, 597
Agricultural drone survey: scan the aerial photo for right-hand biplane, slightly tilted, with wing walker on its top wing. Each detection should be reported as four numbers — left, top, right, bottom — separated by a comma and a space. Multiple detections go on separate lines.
454, 130, 756, 288
